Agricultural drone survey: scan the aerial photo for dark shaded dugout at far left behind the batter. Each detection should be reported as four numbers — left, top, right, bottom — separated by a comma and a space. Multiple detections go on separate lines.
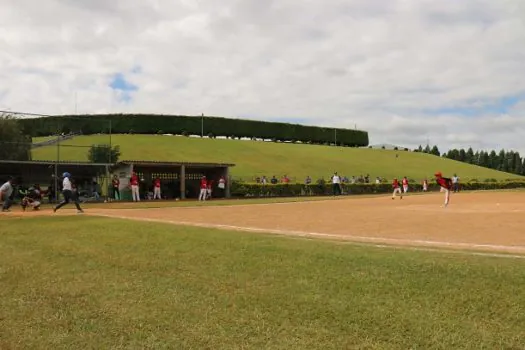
0, 160, 113, 199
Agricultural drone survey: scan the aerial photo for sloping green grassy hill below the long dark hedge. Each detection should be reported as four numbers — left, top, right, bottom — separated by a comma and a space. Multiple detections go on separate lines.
33, 135, 519, 181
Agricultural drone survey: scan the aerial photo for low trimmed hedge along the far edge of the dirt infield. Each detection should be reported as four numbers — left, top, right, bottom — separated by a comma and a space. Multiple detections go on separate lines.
231, 181, 525, 197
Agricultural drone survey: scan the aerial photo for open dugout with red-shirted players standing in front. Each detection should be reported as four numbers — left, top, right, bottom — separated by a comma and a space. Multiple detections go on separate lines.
111, 160, 235, 200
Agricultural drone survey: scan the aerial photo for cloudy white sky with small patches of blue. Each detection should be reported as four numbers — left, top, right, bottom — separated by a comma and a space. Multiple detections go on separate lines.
0, 0, 525, 154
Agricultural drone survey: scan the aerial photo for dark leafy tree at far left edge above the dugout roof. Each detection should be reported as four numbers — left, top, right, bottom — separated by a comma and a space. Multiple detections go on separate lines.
0, 115, 31, 160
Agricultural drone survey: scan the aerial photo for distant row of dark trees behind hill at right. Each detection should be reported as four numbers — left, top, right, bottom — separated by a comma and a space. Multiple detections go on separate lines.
414, 145, 525, 175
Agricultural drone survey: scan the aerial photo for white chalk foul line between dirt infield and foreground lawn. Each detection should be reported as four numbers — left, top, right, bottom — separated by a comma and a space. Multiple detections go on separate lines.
91, 214, 525, 259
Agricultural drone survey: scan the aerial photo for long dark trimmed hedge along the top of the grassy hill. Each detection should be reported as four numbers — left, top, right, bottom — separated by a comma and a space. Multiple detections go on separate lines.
19, 114, 369, 146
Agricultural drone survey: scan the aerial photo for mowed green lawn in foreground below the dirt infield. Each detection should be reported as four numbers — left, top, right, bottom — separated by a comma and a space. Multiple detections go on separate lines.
0, 216, 525, 349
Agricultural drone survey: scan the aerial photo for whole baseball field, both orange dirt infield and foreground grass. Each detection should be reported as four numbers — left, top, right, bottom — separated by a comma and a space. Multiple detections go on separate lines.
0, 191, 525, 349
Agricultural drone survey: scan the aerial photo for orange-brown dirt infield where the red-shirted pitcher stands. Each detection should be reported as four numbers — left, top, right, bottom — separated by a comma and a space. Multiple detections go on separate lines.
4, 192, 525, 254
